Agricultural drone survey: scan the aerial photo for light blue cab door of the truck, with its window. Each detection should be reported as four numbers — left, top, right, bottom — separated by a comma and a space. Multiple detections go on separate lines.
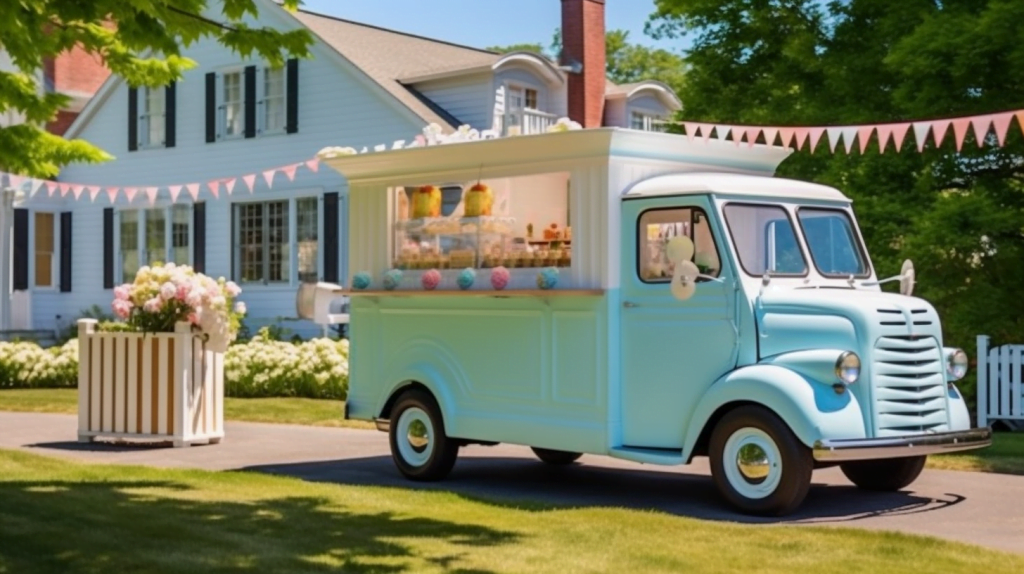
620, 195, 737, 449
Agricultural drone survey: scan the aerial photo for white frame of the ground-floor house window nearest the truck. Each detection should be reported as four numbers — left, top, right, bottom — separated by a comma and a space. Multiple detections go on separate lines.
229, 189, 324, 291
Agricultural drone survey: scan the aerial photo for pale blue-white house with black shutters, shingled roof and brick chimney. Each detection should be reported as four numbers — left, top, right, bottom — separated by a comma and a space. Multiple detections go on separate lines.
13, 0, 680, 334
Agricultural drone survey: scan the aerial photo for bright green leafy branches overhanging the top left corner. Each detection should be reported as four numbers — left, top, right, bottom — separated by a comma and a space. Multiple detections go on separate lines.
0, 0, 312, 177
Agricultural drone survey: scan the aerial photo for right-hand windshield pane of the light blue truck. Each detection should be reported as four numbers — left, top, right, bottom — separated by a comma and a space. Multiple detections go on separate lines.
797, 208, 867, 276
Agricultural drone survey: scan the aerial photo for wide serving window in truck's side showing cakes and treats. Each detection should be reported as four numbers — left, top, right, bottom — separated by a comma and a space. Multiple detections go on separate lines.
389, 173, 572, 270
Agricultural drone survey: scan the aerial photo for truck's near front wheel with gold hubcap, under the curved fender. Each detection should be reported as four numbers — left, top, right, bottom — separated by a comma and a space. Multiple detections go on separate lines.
710, 405, 814, 516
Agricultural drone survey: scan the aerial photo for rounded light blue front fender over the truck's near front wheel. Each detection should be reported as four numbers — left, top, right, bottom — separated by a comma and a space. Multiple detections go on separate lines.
683, 364, 867, 460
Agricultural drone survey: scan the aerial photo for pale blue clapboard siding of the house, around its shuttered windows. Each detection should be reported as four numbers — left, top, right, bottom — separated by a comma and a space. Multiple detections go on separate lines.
50, 4, 423, 335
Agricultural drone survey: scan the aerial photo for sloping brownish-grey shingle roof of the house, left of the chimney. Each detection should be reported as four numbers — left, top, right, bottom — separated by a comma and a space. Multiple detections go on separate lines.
292, 10, 502, 128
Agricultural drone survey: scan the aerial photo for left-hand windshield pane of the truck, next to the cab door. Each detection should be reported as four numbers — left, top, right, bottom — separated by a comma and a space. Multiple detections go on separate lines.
723, 204, 807, 276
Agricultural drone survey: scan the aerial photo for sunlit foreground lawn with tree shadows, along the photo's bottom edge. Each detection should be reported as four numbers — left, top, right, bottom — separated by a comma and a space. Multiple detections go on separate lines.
0, 450, 1024, 574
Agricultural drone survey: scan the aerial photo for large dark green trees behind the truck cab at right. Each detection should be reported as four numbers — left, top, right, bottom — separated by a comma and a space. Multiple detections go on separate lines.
647, 0, 1024, 401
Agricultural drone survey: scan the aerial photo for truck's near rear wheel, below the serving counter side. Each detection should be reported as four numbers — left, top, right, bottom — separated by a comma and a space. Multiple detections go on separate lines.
388, 390, 459, 481
